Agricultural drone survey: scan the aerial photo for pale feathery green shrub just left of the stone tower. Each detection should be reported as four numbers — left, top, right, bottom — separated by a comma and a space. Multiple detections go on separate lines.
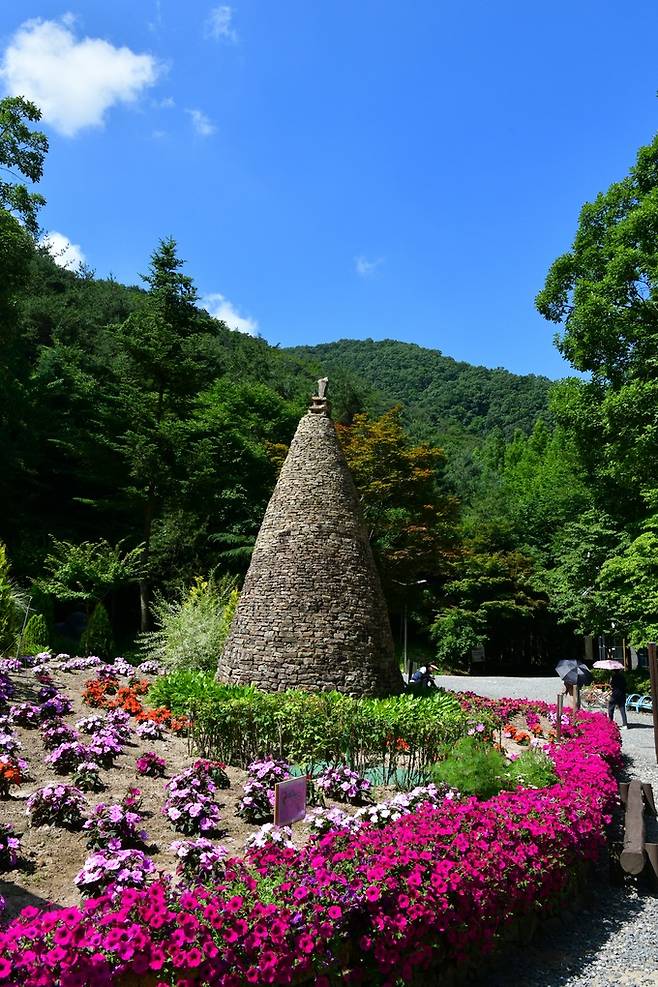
139, 575, 238, 671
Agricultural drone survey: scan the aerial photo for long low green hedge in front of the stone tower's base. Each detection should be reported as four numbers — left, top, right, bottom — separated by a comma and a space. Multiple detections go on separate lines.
161, 671, 466, 787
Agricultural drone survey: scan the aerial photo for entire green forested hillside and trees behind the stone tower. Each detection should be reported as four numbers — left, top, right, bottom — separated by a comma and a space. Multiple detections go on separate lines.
5, 99, 658, 668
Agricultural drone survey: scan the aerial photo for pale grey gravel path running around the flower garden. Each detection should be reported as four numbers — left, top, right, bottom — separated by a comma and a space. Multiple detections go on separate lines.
436, 675, 658, 987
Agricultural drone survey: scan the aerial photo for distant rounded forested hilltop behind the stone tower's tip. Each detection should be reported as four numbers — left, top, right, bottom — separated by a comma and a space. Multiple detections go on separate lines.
287, 339, 551, 444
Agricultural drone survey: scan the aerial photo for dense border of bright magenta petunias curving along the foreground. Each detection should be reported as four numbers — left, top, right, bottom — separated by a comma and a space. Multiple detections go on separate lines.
0, 699, 620, 987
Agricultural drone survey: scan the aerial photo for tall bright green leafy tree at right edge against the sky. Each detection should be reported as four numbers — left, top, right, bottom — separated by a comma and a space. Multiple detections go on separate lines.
537, 130, 658, 520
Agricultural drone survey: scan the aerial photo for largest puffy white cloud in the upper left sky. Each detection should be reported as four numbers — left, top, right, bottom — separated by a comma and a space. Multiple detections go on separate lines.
0, 15, 160, 137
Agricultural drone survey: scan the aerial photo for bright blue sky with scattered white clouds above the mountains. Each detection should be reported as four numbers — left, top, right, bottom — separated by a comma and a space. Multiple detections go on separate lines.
0, 0, 658, 377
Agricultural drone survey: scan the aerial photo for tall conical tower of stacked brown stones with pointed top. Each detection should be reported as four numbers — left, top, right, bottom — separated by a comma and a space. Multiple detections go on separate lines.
217, 380, 401, 696
